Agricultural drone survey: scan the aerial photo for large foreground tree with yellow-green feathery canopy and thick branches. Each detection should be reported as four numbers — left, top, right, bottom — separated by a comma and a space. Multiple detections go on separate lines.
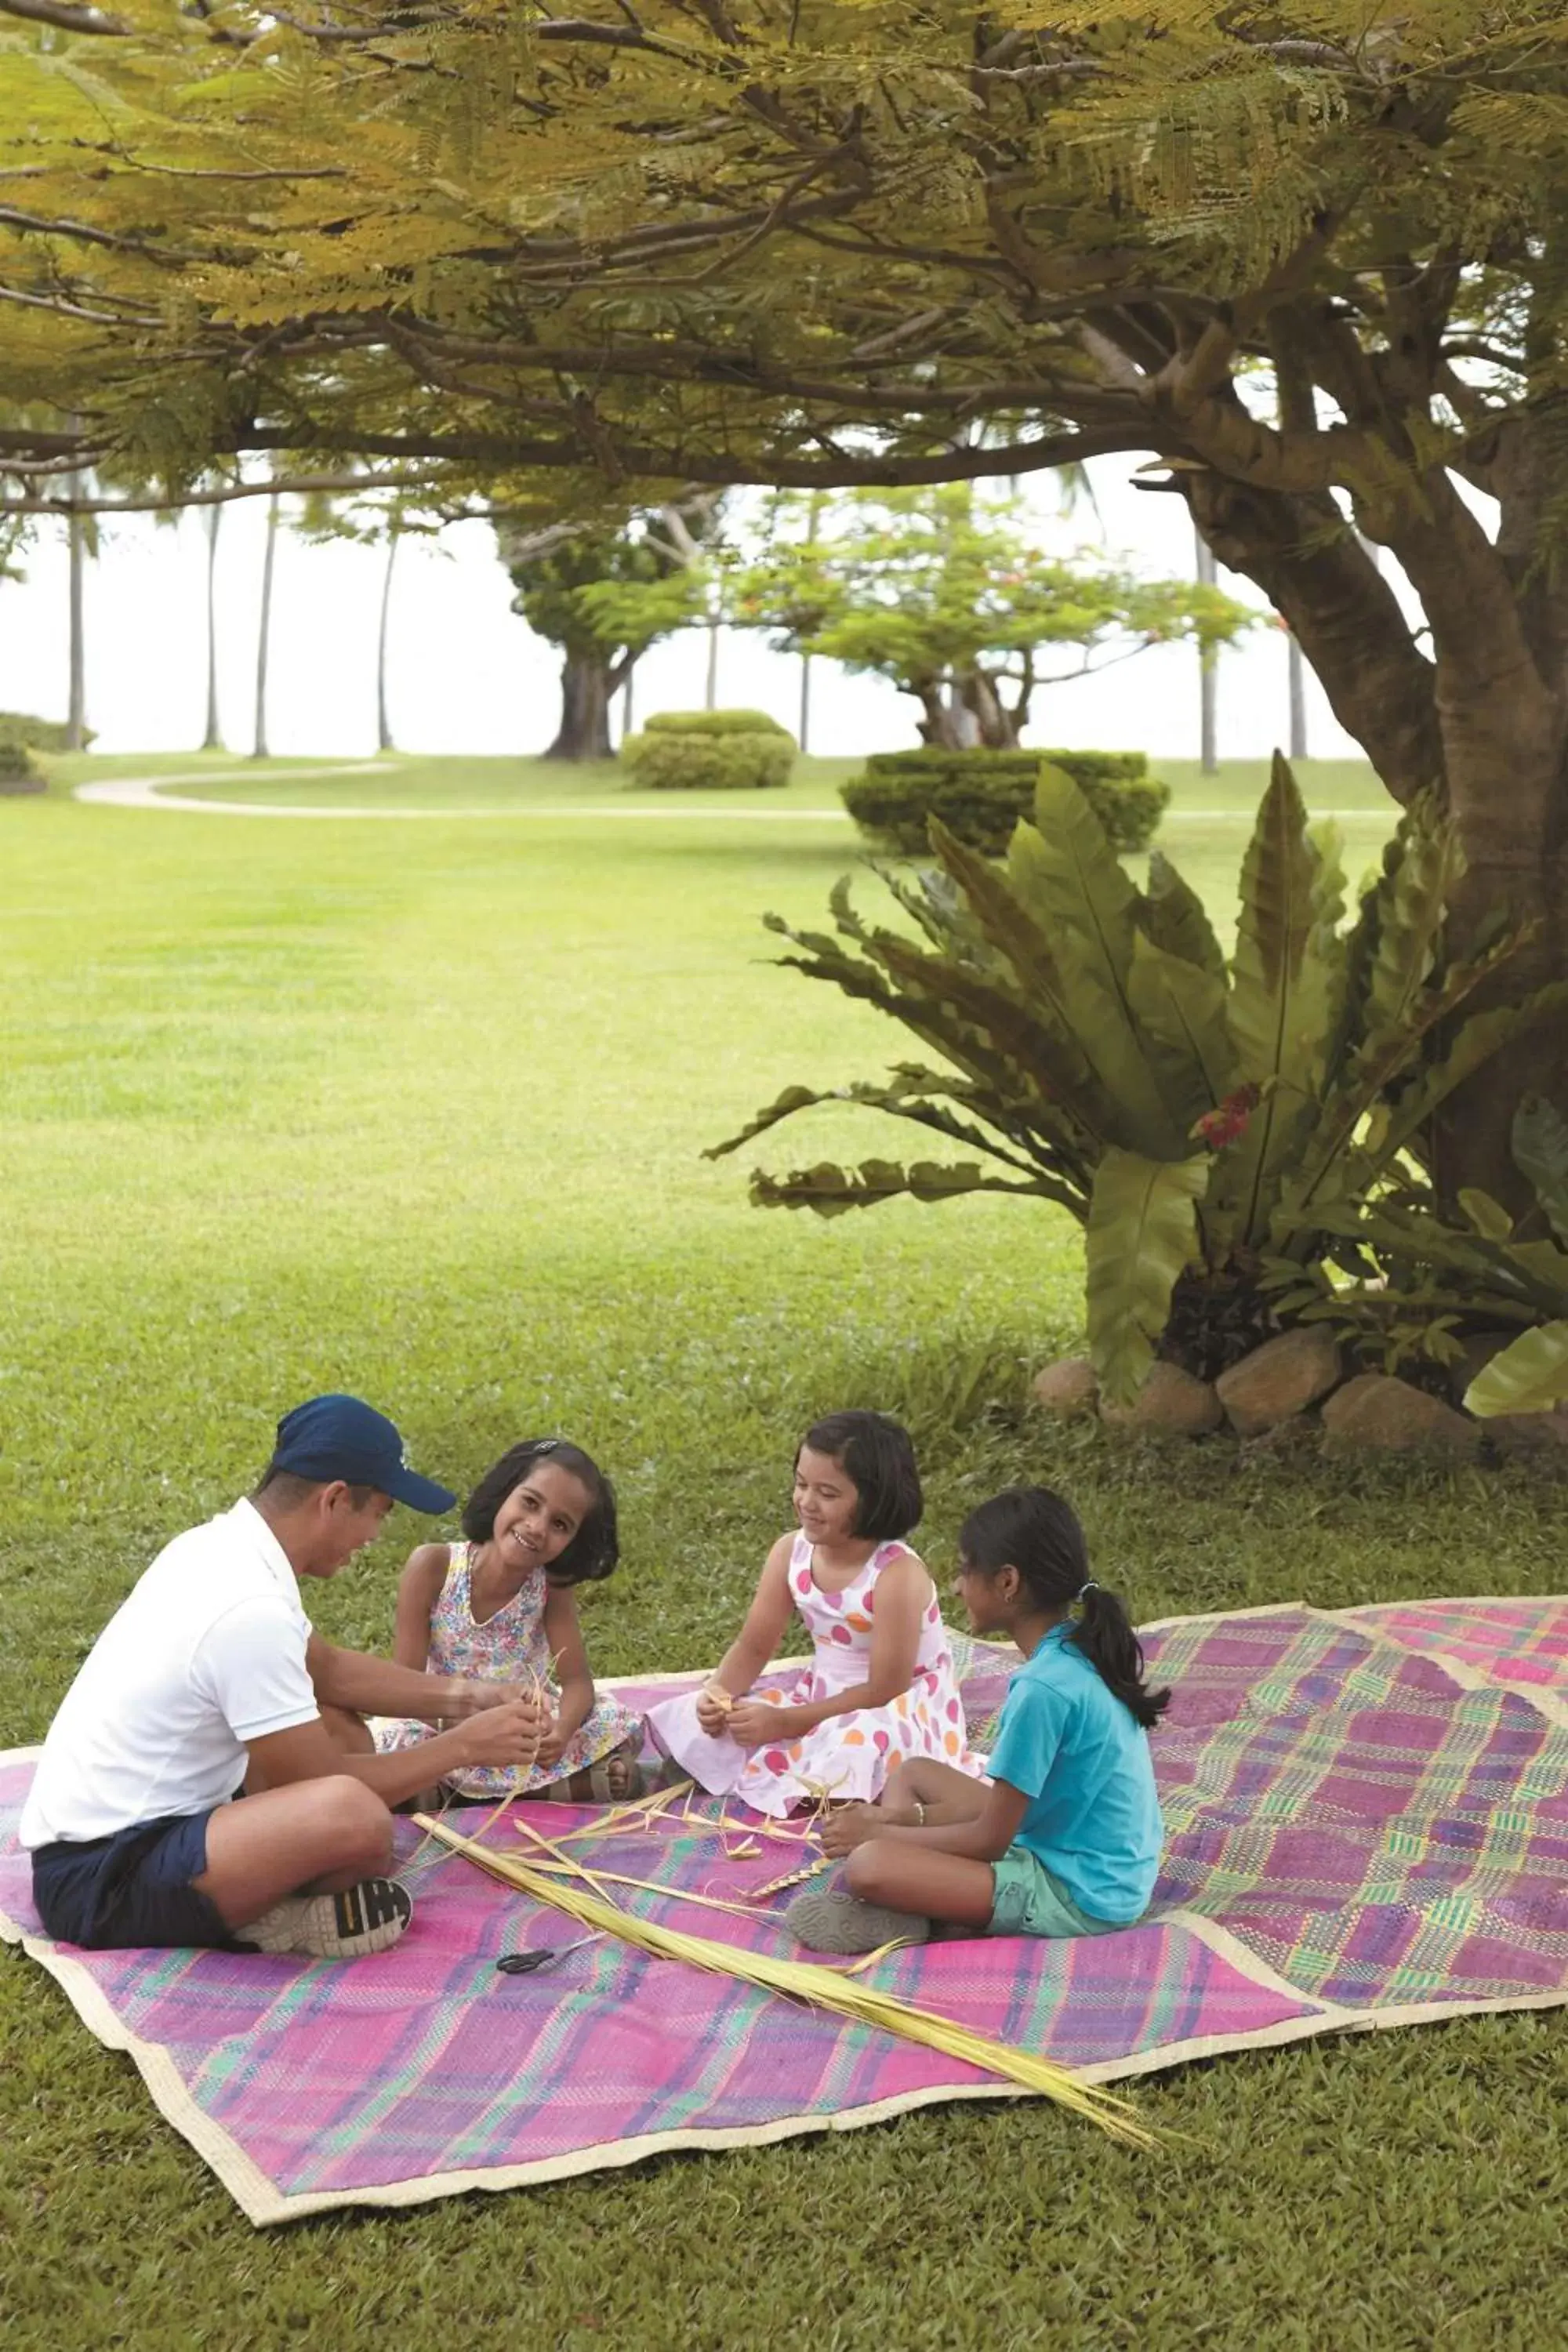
0, 0, 1568, 1185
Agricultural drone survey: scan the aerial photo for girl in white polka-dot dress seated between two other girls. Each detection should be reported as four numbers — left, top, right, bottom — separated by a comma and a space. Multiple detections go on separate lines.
649, 1414, 982, 1818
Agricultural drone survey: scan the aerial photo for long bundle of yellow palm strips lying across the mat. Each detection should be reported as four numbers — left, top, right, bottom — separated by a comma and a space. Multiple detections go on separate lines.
416, 1813, 1156, 2147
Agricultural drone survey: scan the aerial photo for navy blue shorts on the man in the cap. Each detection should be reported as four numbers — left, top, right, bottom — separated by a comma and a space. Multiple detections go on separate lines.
33, 1806, 235, 1952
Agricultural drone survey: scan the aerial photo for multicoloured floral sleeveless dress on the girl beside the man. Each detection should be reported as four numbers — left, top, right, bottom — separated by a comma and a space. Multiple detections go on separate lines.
372, 1543, 642, 1797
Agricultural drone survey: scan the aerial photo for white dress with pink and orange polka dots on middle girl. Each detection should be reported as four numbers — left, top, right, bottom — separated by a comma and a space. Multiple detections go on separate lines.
649, 1534, 982, 1820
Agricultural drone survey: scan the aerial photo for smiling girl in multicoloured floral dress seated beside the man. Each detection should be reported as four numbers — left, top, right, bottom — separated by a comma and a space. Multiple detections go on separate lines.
372, 1437, 642, 1804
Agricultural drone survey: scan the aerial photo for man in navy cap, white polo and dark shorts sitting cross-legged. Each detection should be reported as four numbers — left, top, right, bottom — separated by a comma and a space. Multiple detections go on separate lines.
21, 1397, 541, 1959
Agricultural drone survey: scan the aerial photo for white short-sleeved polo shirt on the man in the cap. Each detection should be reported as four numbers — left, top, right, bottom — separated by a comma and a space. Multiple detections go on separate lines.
19, 1503, 320, 1846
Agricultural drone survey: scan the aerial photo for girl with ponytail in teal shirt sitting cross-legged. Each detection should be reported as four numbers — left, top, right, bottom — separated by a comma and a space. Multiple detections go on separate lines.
787, 1486, 1171, 1952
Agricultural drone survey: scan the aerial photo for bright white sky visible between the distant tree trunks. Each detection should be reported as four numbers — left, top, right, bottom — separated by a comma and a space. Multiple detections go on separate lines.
0, 459, 1401, 757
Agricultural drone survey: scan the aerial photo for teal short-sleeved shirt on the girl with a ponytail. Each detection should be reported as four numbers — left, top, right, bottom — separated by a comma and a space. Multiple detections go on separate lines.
987, 1623, 1166, 1926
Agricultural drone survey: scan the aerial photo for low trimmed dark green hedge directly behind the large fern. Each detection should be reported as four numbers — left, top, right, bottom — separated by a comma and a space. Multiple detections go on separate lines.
844, 746, 1171, 858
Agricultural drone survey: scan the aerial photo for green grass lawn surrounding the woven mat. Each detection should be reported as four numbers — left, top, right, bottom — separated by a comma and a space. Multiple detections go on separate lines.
0, 755, 1568, 2352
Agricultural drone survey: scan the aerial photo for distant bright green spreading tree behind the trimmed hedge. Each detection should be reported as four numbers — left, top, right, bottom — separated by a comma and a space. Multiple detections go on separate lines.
731, 482, 1253, 750
